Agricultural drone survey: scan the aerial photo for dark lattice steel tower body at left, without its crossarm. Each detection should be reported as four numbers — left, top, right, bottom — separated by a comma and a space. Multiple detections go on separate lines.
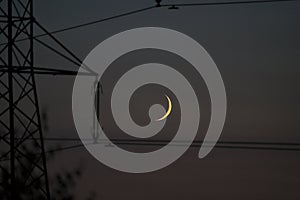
0, 0, 50, 200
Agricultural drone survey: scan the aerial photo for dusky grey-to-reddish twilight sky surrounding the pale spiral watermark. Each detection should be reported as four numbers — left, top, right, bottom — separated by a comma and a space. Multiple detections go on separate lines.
24, 0, 300, 199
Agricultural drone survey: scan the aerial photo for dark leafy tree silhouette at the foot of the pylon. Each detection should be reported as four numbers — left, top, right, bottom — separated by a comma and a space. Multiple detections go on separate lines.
0, 129, 96, 200
